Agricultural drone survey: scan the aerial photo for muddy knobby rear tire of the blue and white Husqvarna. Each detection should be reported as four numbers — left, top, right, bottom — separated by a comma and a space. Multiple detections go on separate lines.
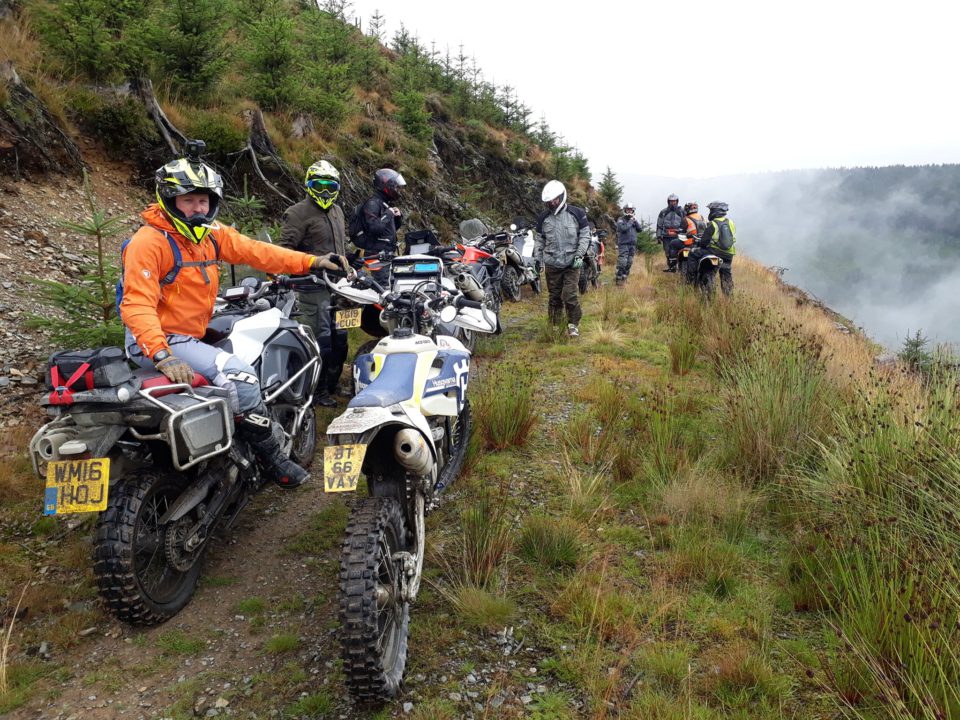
340, 497, 410, 705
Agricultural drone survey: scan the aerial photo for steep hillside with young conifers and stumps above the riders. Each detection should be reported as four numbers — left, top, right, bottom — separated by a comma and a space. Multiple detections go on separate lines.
0, 0, 610, 231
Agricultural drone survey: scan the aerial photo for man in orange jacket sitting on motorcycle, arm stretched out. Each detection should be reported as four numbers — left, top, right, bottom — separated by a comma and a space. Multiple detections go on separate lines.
118, 141, 346, 488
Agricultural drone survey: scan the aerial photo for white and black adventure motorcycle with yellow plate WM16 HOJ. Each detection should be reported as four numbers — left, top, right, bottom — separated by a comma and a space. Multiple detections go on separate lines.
30, 275, 321, 625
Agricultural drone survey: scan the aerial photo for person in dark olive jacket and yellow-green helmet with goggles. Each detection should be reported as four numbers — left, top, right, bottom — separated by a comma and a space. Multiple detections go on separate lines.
280, 160, 349, 407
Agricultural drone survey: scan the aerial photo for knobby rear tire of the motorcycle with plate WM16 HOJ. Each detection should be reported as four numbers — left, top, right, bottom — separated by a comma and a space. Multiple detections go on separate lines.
93, 471, 206, 625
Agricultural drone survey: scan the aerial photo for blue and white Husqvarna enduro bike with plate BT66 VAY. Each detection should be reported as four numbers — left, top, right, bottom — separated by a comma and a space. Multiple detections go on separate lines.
323, 266, 497, 704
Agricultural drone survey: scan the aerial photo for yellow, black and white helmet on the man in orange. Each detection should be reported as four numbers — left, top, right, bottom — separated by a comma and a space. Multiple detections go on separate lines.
156, 148, 223, 244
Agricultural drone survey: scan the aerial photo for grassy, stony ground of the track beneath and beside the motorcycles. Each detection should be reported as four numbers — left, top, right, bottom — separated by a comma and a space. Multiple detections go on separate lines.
0, 243, 960, 720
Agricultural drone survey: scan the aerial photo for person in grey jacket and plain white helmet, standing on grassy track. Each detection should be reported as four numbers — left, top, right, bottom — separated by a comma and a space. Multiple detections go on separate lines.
534, 180, 590, 337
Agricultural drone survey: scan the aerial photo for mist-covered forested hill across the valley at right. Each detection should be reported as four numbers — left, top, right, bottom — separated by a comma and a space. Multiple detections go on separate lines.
621, 165, 960, 350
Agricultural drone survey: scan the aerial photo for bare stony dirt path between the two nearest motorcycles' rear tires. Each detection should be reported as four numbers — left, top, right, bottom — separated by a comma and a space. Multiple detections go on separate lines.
10, 472, 362, 720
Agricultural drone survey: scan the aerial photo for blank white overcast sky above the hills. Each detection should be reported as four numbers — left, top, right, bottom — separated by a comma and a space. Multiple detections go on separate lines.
353, 0, 960, 181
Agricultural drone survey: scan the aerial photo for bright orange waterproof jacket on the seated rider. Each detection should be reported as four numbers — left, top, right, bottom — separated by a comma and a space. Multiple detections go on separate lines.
120, 204, 313, 358
